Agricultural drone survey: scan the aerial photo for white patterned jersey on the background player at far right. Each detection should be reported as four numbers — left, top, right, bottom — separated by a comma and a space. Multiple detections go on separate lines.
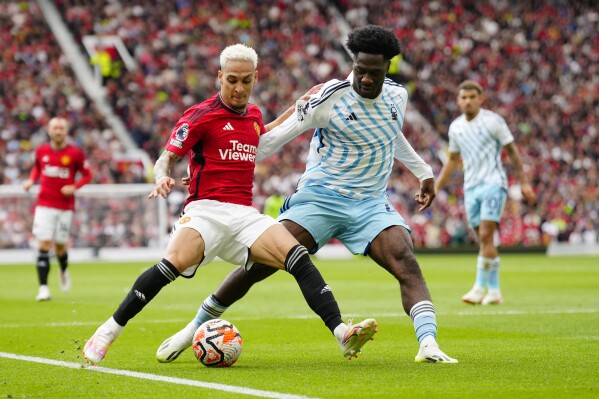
449, 108, 514, 189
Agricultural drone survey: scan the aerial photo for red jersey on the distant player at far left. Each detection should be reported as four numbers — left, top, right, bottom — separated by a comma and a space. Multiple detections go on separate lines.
30, 143, 91, 210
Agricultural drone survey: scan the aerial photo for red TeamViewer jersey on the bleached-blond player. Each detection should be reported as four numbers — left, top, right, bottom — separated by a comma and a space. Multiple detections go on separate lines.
165, 93, 266, 206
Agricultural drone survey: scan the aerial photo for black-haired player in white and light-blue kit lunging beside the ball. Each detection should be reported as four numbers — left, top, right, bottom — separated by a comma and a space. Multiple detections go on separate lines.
156, 26, 457, 363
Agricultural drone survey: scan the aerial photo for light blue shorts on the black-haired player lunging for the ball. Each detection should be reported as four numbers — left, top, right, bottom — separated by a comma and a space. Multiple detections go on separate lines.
277, 187, 410, 255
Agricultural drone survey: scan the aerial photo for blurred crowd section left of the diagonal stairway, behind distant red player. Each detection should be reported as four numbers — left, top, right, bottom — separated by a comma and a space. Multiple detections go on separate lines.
0, 2, 135, 184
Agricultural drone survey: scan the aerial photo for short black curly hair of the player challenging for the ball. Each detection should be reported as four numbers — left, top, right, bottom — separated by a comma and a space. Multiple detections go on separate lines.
346, 25, 401, 60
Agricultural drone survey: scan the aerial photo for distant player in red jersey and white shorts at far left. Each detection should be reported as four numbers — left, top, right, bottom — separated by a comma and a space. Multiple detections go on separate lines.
23, 117, 92, 301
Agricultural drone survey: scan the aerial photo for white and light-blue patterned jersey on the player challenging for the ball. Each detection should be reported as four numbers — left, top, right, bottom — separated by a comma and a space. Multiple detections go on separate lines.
257, 79, 433, 199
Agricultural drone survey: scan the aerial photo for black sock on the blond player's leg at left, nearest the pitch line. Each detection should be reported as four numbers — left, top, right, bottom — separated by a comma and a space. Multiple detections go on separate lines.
112, 259, 180, 326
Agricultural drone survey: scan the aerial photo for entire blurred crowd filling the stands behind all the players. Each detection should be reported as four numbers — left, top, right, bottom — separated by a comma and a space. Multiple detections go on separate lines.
0, 0, 599, 247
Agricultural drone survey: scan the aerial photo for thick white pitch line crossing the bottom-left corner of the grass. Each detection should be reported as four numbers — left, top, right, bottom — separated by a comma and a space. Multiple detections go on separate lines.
0, 352, 318, 399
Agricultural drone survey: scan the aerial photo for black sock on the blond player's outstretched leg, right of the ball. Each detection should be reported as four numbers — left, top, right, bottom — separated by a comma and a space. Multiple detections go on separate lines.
285, 245, 343, 332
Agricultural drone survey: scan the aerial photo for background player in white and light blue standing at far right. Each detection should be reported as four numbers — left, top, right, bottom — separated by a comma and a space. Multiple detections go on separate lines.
436, 80, 536, 305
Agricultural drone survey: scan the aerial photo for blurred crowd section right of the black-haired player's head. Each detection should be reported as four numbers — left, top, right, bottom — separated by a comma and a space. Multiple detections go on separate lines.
338, 0, 599, 245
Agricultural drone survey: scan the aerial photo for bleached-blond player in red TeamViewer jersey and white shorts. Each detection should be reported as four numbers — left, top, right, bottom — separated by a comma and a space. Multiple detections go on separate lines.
83, 44, 376, 364
